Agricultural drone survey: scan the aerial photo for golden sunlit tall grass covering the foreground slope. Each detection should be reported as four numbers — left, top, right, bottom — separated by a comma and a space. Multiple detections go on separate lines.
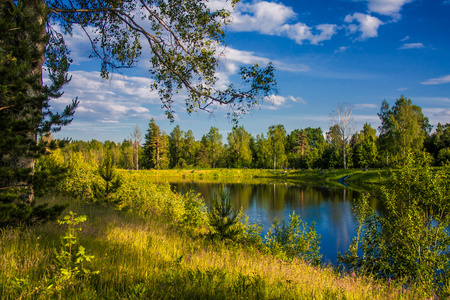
0, 198, 428, 299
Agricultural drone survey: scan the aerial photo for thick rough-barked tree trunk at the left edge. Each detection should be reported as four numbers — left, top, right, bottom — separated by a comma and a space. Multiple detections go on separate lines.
0, 0, 48, 205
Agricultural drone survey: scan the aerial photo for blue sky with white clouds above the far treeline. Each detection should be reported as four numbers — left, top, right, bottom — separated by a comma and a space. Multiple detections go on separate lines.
52, 0, 450, 142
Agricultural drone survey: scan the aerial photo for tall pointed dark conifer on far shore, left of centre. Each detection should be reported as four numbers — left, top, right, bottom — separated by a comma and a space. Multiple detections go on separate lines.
142, 118, 169, 169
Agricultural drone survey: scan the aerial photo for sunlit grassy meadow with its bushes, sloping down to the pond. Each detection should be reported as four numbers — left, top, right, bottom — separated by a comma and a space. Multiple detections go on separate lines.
0, 152, 444, 299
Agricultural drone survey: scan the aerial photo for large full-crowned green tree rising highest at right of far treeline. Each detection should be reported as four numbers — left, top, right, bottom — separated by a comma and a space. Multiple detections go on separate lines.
378, 96, 431, 165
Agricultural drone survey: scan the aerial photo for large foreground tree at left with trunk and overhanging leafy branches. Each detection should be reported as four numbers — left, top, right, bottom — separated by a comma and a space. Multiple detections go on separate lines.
0, 0, 276, 220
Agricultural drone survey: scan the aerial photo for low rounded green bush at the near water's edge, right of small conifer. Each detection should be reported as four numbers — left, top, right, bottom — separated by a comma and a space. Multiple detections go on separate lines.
265, 212, 322, 265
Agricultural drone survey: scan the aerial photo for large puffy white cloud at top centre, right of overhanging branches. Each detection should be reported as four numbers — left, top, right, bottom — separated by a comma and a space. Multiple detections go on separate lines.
231, 1, 337, 45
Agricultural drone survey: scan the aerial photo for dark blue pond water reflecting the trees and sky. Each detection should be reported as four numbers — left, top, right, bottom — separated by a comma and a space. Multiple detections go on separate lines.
171, 182, 377, 264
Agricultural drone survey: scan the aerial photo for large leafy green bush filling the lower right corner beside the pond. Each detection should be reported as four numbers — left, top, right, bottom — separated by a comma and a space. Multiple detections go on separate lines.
340, 153, 450, 297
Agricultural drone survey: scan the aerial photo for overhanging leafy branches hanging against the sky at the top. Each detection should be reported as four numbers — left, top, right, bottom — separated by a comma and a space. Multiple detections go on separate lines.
46, 0, 276, 121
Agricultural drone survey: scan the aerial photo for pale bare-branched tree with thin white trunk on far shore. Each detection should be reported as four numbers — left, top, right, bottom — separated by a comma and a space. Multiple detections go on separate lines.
331, 104, 353, 169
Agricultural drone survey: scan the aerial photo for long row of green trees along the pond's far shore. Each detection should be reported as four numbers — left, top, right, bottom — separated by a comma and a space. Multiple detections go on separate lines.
63, 96, 450, 169
